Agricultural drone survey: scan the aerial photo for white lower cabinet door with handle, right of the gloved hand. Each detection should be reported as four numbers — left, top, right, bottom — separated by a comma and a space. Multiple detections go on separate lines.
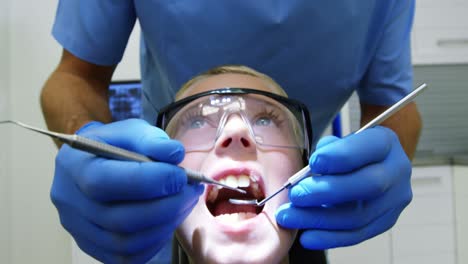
392, 166, 456, 264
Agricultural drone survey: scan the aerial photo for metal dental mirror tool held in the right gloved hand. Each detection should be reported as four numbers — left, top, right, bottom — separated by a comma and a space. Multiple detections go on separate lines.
229, 83, 427, 206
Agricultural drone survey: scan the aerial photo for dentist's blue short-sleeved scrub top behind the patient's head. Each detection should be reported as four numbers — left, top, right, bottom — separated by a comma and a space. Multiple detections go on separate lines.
53, 0, 414, 142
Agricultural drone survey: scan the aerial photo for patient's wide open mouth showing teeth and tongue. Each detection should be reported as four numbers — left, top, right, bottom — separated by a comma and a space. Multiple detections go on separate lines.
206, 174, 265, 221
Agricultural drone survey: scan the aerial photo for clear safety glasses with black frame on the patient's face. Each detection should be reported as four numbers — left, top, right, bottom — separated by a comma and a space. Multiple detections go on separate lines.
156, 88, 312, 157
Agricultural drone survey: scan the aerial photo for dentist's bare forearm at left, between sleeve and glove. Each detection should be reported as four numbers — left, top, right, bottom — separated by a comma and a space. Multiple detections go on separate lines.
40, 48, 113, 145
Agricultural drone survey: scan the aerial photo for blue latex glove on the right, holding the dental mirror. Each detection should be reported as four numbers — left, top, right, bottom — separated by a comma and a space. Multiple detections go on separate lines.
276, 126, 412, 249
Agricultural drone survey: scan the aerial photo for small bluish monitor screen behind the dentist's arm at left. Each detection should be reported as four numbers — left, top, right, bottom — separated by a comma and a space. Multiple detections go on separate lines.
109, 80, 141, 121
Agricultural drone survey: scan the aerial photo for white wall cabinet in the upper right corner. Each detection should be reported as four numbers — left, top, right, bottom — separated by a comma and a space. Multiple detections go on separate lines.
412, 0, 468, 64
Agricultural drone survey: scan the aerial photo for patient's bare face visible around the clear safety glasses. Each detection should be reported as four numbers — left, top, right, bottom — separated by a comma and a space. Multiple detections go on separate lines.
177, 74, 302, 263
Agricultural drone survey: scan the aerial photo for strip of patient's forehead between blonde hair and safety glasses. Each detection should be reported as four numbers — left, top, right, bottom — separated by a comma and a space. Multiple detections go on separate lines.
178, 73, 281, 99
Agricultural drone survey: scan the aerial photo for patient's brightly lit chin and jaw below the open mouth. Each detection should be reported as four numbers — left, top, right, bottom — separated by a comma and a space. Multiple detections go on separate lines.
177, 213, 295, 263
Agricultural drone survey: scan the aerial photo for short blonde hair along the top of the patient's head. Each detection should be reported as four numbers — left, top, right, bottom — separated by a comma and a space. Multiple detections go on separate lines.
175, 65, 288, 100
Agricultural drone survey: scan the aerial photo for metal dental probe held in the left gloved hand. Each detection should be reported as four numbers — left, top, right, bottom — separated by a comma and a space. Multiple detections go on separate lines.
0, 120, 246, 193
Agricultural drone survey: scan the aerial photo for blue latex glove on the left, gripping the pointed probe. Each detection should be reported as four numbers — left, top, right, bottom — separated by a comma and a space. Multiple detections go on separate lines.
51, 119, 203, 263
